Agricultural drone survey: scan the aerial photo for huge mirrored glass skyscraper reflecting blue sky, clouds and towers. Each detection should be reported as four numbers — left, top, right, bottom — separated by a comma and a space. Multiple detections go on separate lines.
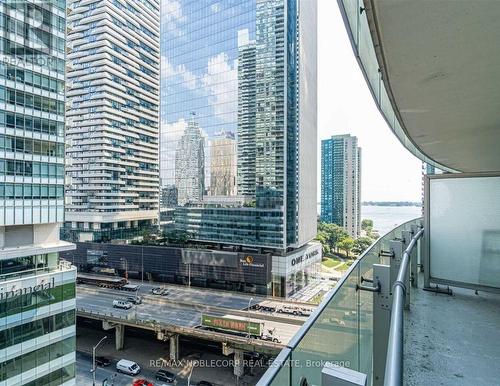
161, 0, 317, 251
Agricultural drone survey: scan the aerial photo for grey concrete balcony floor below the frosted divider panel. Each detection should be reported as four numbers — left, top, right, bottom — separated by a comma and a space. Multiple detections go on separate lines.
404, 280, 500, 386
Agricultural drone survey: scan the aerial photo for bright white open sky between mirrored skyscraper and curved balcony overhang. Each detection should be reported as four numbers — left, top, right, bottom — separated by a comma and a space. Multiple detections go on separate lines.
318, 0, 422, 201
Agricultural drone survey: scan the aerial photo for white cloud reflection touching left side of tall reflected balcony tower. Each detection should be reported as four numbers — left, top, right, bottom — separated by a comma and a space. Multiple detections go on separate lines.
201, 52, 238, 122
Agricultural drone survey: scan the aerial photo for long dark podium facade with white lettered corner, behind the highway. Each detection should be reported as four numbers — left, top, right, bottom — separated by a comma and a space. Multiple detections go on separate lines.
60, 243, 321, 298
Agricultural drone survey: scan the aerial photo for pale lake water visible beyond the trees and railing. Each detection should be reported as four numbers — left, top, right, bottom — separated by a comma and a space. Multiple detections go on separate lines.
361, 205, 422, 236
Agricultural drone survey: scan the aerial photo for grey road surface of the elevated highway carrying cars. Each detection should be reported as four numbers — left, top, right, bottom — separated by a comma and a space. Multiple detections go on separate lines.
77, 283, 305, 344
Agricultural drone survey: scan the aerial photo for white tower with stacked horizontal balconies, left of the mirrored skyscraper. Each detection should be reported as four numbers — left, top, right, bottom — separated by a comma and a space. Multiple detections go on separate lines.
65, 0, 160, 241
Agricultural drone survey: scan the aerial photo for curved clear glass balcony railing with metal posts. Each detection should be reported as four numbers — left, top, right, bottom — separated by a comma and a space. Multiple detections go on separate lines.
258, 219, 423, 386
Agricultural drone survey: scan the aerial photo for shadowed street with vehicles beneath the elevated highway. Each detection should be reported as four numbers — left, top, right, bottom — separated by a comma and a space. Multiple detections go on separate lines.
77, 322, 272, 386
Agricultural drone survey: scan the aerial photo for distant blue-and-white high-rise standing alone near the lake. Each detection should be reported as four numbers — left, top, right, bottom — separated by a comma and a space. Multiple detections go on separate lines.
321, 134, 361, 237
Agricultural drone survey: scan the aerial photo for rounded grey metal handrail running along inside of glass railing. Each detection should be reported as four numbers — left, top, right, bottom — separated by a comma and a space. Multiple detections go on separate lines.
384, 228, 424, 386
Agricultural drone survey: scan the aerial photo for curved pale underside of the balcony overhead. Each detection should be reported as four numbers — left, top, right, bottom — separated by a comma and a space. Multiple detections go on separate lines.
364, 0, 500, 172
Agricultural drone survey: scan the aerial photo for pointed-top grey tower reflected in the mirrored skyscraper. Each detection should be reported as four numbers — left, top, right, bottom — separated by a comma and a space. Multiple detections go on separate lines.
175, 114, 205, 205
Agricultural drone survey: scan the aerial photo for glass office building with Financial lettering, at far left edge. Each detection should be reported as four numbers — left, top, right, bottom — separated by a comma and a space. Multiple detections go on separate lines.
0, 0, 76, 386
